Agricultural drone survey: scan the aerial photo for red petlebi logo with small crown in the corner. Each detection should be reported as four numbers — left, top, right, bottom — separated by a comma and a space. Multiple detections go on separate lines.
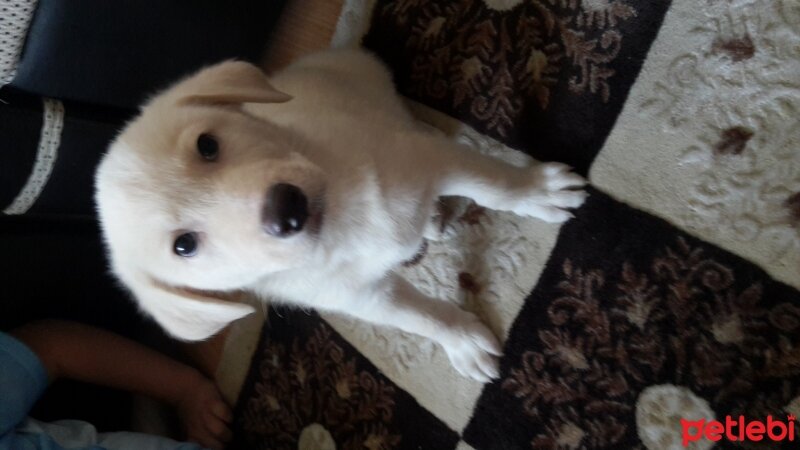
681, 414, 795, 447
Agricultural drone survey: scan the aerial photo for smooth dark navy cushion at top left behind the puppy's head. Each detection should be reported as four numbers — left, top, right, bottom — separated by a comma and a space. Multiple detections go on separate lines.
11, 0, 285, 108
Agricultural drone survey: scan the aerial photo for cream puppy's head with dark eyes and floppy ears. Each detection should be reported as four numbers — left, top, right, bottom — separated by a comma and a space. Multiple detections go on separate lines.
96, 62, 325, 340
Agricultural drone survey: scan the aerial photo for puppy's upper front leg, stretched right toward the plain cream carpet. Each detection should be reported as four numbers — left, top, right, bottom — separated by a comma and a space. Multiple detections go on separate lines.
431, 136, 587, 223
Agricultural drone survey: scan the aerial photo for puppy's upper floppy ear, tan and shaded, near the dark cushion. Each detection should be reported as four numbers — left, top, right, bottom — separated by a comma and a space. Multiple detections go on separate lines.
175, 61, 292, 104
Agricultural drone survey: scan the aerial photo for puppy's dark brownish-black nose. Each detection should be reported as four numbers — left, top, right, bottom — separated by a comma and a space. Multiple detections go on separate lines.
261, 183, 308, 238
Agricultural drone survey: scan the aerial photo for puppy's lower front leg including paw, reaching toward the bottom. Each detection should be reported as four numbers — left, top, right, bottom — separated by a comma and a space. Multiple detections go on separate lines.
347, 275, 501, 382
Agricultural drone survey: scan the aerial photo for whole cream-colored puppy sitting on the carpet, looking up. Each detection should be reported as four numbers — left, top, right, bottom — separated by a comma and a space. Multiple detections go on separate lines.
96, 50, 585, 381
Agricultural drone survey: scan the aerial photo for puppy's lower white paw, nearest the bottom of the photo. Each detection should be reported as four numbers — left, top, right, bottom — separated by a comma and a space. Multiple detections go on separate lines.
440, 312, 502, 383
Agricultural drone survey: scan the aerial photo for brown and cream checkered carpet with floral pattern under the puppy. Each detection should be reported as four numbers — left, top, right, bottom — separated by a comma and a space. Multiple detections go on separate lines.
227, 0, 800, 450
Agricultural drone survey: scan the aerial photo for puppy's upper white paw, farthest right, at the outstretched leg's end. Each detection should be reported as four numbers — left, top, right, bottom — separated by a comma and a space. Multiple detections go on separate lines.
503, 163, 588, 223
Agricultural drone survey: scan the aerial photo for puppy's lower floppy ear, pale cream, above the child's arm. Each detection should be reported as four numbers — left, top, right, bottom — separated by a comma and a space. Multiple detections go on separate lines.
125, 274, 255, 341
